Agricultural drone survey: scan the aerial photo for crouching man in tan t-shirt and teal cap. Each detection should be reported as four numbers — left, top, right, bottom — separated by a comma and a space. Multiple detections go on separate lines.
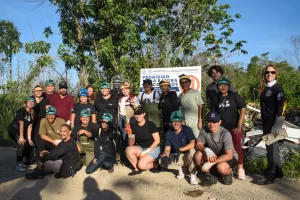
38, 106, 66, 151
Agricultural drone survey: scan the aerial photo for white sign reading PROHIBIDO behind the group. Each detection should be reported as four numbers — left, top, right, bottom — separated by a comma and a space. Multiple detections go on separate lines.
140, 66, 201, 95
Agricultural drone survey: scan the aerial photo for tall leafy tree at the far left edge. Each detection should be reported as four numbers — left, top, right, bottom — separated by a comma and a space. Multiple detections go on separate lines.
0, 20, 22, 82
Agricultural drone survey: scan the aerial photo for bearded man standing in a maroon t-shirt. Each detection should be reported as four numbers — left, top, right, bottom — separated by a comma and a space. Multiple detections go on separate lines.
51, 81, 74, 124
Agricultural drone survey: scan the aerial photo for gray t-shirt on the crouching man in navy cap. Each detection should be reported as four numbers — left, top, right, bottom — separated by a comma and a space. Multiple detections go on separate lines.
197, 126, 238, 159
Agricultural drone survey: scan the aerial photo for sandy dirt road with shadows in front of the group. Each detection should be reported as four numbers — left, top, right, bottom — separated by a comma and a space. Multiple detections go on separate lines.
0, 147, 300, 200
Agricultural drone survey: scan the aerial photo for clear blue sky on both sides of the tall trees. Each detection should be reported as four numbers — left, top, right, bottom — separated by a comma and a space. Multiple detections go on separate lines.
0, 0, 300, 81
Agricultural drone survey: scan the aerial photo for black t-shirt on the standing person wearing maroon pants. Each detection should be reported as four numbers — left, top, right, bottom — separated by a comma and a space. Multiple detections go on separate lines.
216, 91, 246, 131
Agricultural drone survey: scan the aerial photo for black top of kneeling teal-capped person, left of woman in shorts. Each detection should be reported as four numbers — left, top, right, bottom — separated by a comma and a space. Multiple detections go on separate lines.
94, 128, 116, 155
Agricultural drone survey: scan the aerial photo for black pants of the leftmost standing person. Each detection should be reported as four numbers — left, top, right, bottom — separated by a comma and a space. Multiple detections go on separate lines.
7, 125, 32, 163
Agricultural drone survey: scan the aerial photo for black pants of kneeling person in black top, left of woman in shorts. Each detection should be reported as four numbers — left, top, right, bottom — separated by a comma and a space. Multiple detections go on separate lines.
85, 151, 116, 174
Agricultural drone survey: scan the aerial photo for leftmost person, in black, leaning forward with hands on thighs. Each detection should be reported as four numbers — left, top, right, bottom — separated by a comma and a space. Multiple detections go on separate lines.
7, 96, 35, 172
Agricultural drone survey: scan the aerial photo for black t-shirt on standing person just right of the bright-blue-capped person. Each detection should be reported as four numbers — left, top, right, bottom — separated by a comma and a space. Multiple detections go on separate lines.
94, 94, 118, 122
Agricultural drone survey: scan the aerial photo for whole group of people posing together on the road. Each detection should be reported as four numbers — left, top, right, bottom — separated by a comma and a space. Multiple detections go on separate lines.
8, 65, 284, 186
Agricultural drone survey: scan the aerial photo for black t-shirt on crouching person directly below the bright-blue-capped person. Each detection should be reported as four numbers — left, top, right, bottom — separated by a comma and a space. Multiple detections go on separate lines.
72, 123, 100, 141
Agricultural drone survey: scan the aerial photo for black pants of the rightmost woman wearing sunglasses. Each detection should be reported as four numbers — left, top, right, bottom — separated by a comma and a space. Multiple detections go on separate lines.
263, 118, 282, 174
